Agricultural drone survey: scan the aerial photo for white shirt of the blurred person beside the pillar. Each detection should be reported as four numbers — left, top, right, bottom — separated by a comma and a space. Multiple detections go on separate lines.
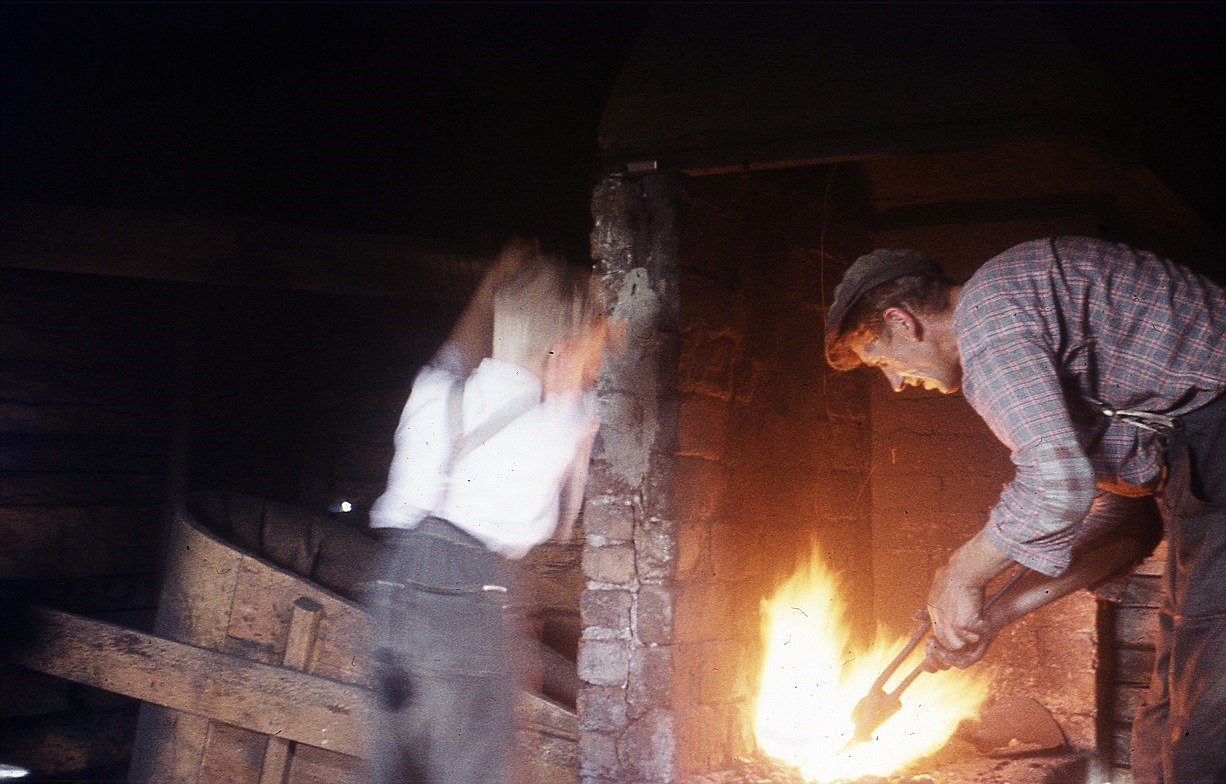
370, 347, 600, 558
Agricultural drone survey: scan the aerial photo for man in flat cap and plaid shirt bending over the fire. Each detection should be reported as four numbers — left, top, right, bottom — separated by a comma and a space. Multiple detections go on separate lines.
826, 237, 1226, 784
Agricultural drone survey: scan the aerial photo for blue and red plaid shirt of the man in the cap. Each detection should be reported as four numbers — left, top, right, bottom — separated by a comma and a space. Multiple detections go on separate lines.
954, 237, 1226, 575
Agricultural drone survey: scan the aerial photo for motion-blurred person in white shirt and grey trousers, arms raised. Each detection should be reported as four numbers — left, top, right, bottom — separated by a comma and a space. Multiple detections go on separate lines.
369, 240, 607, 784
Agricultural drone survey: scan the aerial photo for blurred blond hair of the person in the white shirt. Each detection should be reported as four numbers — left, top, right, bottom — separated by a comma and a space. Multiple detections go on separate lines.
494, 255, 603, 375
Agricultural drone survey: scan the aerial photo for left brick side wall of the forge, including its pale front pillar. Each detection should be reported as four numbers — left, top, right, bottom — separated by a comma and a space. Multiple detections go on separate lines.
579, 175, 887, 784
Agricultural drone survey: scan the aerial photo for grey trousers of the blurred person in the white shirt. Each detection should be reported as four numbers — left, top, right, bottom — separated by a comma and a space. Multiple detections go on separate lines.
368, 519, 515, 784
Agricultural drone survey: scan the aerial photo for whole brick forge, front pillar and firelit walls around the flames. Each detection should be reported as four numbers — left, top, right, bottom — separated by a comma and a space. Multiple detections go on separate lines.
577, 167, 1144, 784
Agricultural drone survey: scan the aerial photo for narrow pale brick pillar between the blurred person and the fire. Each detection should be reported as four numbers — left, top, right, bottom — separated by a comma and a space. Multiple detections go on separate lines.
579, 174, 679, 784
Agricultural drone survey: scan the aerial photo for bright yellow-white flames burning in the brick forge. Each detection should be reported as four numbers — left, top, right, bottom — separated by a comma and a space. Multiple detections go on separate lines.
754, 548, 988, 782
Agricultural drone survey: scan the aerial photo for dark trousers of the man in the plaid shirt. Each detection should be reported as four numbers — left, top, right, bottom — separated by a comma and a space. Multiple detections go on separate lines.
1132, 398, 1226, 784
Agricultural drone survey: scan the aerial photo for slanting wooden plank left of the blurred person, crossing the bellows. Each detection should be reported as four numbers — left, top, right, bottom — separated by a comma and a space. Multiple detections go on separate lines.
16, 609, 370, 756
